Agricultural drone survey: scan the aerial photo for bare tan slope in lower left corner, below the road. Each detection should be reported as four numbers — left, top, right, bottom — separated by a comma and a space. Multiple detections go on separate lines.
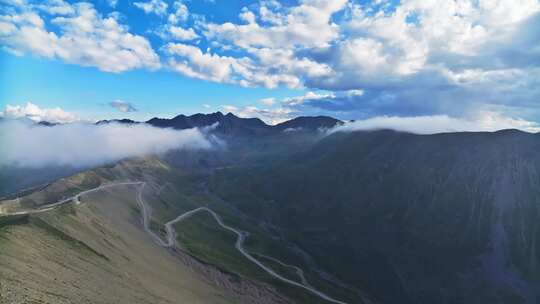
0, 187, 235, 303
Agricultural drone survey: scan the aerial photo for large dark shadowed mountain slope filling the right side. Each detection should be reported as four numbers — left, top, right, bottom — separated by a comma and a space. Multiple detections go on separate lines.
213, 130, 540, 303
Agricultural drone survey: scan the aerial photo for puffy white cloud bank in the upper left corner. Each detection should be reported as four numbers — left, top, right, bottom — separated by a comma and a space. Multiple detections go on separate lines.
0, 3, 160, 72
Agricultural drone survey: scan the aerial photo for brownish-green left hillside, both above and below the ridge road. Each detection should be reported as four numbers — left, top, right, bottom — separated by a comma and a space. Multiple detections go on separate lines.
0, 159, 296, 304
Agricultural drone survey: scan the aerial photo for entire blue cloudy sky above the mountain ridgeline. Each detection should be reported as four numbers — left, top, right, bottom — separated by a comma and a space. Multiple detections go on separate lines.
0, 0, 540, 131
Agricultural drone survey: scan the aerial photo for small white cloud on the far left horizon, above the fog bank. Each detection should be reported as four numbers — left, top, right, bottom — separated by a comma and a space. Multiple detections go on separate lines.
0, 102, 79, 123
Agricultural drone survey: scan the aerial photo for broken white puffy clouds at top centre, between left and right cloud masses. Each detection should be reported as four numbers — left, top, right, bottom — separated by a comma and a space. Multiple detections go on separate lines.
162, 0, 345, 88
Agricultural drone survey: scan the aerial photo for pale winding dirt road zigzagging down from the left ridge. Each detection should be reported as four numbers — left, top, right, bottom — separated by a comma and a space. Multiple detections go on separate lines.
0, 182, 347, 304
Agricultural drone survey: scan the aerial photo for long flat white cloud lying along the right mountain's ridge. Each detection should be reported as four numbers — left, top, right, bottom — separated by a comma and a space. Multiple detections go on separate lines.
329, 112, 540, 134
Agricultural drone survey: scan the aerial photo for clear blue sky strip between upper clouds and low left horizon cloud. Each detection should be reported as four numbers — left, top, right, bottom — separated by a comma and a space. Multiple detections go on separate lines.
0, 52, 301, 120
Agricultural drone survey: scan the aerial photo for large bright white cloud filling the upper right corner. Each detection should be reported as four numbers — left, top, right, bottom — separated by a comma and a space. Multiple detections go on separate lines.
316, 0, 540, 88
